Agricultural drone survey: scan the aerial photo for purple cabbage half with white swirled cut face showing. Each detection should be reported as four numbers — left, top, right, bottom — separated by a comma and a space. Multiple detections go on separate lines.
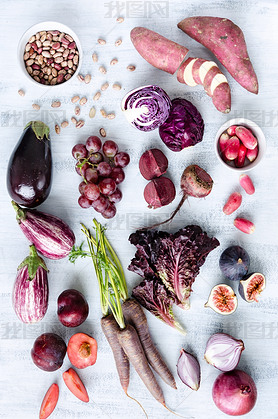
122, 85, 171, 131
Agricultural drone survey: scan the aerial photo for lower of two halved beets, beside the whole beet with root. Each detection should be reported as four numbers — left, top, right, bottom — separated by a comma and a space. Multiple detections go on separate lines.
144, 177, 176, 209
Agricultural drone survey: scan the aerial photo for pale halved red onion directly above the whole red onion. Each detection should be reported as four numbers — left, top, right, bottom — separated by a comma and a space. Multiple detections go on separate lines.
205, 333, 244, 371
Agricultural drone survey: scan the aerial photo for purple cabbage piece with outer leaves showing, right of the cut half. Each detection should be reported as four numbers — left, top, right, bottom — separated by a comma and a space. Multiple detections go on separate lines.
159, 98, 204, 151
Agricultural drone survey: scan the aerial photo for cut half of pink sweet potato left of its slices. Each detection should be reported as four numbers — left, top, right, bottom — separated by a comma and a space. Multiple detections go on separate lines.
130, 27, 188, 74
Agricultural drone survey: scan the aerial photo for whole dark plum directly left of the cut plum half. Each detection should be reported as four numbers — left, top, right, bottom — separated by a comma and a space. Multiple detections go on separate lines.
31, 333, 67, 371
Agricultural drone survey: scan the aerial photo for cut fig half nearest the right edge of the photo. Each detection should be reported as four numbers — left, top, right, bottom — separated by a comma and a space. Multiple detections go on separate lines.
238, 272, 265, 303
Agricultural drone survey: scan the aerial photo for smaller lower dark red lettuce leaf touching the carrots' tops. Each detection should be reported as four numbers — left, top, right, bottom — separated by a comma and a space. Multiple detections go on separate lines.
132, 278, 186, 334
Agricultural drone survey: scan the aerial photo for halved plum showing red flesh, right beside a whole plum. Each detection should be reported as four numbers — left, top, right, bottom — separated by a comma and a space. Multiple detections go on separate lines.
67, 333, 97, 369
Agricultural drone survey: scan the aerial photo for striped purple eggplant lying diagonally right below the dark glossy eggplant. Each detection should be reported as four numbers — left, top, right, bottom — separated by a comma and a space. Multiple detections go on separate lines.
12, 201, 75, 259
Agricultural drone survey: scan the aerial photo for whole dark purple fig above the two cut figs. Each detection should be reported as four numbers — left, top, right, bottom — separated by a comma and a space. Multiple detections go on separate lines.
219, 246, 250, 281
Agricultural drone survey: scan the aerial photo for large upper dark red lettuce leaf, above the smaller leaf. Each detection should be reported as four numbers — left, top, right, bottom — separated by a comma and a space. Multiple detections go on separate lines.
128, 225, 219, 318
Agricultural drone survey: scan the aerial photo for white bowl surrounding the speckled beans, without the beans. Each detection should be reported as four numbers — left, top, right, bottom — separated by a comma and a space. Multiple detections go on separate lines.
17, 21, 83, 89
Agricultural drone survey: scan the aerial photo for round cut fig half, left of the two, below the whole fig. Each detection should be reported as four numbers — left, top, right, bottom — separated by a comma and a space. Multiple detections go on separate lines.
205, 284, 237, 315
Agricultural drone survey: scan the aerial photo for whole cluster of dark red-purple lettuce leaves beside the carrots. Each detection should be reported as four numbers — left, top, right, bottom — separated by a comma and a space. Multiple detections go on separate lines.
128, 225, 219, 327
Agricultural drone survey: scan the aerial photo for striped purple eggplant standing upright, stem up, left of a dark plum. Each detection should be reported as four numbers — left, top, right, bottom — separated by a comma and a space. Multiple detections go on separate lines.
13, 245, 48, 323
